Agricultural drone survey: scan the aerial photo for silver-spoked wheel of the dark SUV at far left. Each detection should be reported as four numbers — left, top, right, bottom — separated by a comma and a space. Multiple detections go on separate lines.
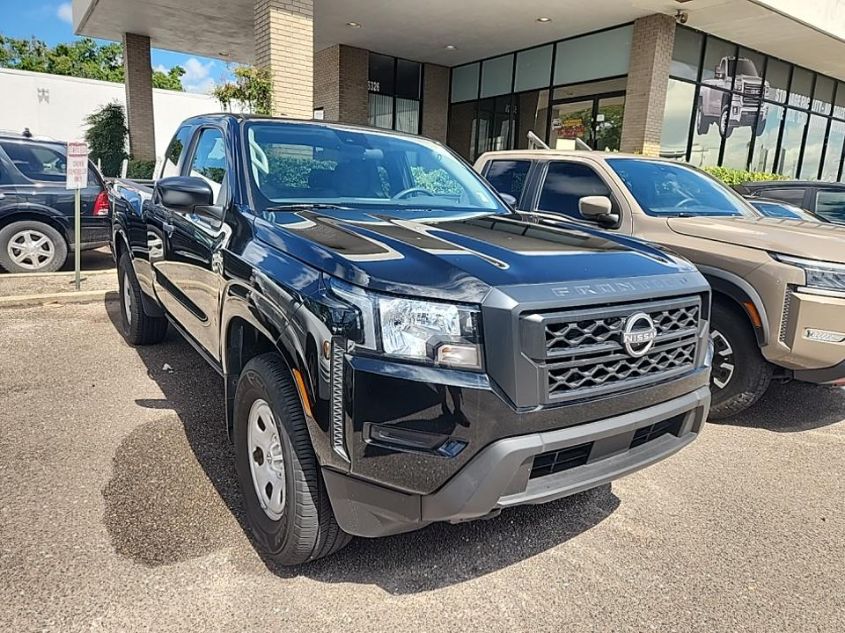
0, 220, 67, 273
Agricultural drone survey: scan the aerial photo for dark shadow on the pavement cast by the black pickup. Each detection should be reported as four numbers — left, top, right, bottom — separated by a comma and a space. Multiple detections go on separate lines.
103, 296, 619, 594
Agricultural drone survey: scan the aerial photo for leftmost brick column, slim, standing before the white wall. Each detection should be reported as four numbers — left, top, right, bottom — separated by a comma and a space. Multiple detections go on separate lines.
123, 33, 156, 160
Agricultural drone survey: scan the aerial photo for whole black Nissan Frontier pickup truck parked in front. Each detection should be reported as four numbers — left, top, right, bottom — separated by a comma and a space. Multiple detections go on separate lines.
111, 114, 711, 564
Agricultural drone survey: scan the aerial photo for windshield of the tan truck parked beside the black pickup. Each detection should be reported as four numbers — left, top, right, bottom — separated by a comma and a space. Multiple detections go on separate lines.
607, 158, 756, 216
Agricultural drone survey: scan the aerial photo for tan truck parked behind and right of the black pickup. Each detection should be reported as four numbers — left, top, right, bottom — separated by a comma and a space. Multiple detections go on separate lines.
475, 150, 845, 418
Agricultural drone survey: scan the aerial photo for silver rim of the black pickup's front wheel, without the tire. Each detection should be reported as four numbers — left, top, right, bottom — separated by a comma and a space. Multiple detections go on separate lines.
246, 398, 285, 521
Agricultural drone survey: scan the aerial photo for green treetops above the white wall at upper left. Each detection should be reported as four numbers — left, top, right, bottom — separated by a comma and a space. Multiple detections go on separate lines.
0, 34, 185, 90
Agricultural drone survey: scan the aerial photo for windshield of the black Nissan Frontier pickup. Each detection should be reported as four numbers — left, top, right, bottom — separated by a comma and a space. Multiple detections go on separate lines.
245, 121, 508, 213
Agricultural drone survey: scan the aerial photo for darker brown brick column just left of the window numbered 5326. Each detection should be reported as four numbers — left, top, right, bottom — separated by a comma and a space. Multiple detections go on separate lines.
314, 44, 370, 125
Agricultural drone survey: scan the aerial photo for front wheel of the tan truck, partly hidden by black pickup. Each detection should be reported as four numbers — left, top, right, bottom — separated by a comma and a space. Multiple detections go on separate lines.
710, 301, 773, 420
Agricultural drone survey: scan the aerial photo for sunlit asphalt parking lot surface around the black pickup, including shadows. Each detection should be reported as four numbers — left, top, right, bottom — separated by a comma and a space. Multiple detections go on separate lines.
0, 302, 845, 633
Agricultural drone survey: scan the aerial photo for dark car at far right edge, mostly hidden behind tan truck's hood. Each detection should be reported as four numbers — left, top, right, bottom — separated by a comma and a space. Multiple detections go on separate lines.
735, 180, 845, 224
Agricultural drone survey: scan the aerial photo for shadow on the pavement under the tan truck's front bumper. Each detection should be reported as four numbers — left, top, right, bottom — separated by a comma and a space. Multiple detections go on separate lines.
716, 382, 845, 433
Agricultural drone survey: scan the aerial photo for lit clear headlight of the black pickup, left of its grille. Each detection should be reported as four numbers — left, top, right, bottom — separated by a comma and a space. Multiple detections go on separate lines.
330, 279, 482, 369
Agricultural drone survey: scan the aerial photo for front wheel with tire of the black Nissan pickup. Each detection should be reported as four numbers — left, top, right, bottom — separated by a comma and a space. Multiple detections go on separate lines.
233, 353, 352, 565
